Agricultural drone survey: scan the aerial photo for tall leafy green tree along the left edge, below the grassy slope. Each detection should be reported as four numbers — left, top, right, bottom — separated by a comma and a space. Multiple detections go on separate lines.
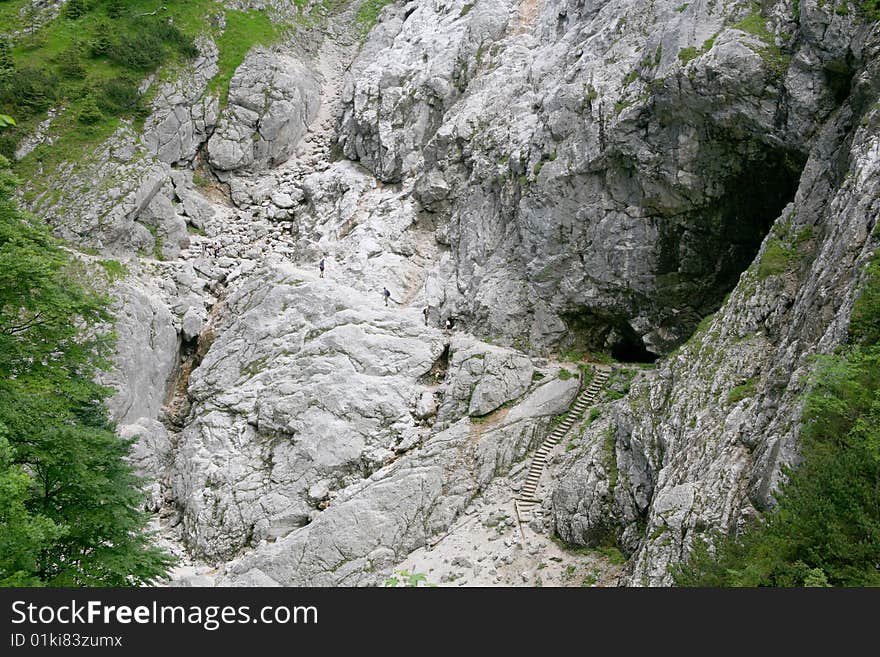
0, 159, 171, 586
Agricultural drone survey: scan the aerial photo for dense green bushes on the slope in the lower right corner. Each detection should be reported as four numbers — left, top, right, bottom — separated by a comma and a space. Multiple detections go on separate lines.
674, 245, 880, 587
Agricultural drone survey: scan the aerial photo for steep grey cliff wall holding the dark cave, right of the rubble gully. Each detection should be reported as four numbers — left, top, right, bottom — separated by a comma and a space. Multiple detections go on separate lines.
340, 2, 868, 354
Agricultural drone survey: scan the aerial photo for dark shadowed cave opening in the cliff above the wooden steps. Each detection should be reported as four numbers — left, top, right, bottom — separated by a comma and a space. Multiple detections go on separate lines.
560, 142, 806, 363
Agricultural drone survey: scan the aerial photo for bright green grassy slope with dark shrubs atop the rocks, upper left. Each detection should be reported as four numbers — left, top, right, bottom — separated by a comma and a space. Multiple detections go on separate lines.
0, 0, 278, 179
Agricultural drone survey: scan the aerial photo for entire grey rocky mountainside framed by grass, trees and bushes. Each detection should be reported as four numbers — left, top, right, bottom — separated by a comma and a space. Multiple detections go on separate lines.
10, 0, 880, 585
